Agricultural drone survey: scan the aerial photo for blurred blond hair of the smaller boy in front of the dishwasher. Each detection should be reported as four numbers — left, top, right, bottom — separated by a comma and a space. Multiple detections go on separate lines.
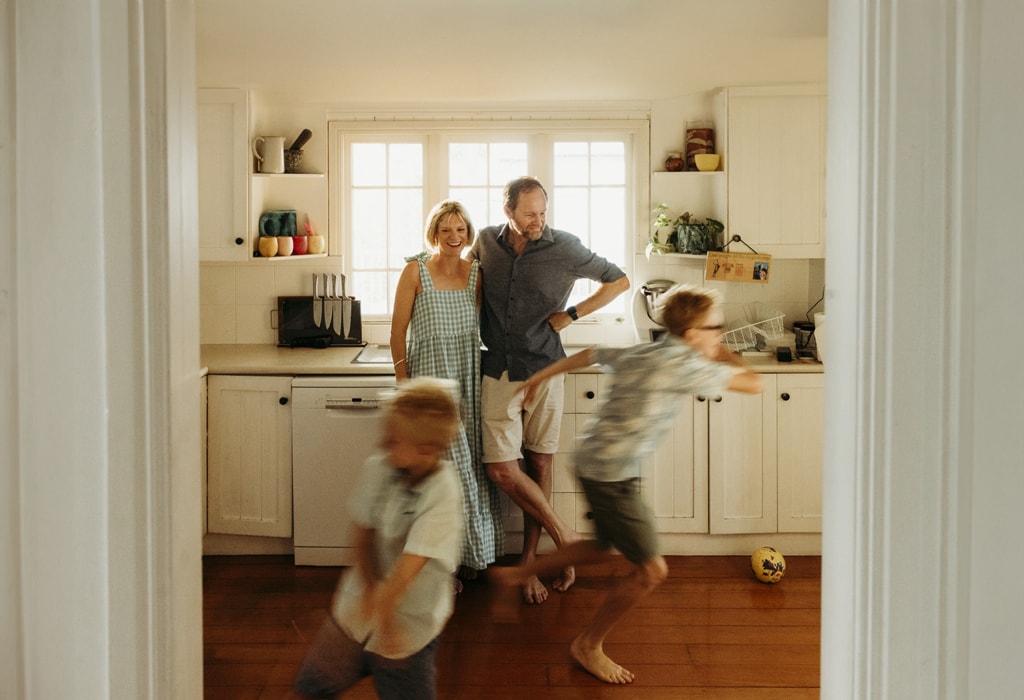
387, 377, 459, 449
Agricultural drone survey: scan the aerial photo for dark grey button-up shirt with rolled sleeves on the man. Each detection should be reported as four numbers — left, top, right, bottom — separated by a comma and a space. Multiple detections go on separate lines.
469, 224, 626, 382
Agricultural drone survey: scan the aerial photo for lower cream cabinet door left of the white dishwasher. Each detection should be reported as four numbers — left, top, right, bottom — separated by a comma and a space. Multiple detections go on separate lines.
207, 376, 292, 537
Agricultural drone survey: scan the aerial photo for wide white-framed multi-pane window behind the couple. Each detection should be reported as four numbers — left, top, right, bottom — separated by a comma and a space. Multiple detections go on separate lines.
329, 120, 647, 320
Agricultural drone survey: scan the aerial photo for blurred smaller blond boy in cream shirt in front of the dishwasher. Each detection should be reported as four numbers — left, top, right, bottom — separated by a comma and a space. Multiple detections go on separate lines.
294, 378, 463, 699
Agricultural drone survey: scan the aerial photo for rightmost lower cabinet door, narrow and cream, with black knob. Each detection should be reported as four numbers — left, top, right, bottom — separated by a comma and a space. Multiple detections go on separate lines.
775, 375, 824, 532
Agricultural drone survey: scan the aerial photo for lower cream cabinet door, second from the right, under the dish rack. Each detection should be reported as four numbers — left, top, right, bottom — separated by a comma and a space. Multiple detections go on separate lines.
697, 375, 778, 534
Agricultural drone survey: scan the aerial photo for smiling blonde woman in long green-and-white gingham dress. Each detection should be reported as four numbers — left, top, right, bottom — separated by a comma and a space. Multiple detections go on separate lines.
391, 200, 505, 578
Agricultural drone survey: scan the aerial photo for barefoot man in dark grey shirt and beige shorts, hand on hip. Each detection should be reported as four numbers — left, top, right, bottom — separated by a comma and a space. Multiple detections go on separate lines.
469, 177, 630, 603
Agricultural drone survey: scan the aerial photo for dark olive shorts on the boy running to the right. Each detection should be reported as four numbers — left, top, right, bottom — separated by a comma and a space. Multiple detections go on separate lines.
580, 472, 658, 564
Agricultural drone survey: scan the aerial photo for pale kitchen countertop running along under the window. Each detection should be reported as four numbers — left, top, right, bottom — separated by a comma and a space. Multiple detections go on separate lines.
200, 345, 824, 376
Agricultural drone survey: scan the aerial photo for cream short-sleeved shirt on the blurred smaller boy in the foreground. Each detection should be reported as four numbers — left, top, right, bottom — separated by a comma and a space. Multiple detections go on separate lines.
332, 452, 463, 659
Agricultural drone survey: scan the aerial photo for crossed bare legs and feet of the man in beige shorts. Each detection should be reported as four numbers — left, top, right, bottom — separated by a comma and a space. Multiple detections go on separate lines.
485, 451, 580, 603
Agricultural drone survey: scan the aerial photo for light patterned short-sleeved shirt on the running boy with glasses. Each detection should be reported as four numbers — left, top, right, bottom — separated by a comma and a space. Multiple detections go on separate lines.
575, 335, 735, 482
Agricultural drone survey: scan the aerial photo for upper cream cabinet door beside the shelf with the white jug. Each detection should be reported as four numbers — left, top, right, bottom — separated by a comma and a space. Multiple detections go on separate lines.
197, 89, 249, 261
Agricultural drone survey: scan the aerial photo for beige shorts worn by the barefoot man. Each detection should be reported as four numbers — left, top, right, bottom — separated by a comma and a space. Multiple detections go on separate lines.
480, 371, 565, 464
